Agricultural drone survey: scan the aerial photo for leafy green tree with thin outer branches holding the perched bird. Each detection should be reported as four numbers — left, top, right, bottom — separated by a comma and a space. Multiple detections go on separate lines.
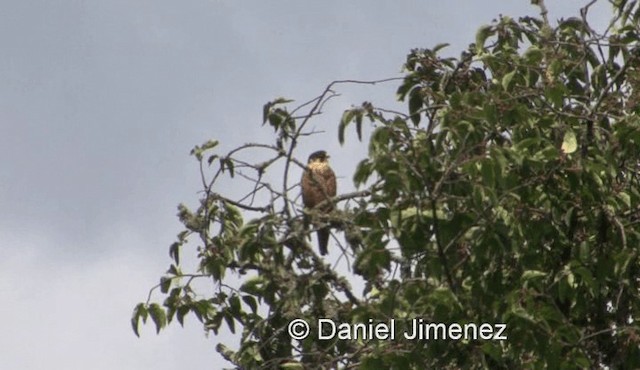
132, 0, 640, 369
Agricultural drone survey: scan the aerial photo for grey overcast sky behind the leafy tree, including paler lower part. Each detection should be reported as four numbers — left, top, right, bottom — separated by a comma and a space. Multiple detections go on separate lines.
0, 0, 608, 370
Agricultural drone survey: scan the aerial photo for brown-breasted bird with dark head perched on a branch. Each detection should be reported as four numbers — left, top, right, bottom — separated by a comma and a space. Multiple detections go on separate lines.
300, 150, 337, 256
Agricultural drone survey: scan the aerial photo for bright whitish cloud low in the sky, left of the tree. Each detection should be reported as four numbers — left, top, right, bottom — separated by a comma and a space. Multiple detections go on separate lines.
0, 231, 220, 370
